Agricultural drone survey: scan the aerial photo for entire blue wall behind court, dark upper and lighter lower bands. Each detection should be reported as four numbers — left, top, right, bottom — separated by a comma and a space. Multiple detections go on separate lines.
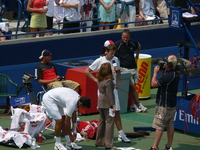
0, 25, 200, 104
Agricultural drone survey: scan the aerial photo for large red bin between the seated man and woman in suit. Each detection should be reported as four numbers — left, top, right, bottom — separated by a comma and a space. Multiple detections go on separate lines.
65, 67, 98, 114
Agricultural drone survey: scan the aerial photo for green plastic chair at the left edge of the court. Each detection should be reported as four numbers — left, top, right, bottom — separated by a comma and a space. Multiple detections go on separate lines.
0, 73, 18, 104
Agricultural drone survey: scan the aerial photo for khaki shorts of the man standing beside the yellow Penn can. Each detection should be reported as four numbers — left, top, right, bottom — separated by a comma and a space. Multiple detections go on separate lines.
120, 67, 139, 85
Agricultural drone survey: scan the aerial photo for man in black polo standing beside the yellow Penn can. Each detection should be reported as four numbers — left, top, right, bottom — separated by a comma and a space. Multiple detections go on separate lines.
115, 29, 147, 112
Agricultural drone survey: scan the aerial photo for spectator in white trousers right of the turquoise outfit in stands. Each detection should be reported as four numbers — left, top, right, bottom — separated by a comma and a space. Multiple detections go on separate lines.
117, 0, 136, 28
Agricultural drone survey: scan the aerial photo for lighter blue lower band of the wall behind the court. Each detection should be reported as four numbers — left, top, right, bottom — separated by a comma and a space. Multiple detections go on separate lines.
0, 46, 200, 99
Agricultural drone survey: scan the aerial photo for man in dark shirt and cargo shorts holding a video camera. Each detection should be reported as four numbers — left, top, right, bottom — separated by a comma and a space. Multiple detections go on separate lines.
150, 55, 179, 150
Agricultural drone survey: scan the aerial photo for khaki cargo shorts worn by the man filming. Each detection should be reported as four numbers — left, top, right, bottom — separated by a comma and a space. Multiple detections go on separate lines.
152, 106, 176, 130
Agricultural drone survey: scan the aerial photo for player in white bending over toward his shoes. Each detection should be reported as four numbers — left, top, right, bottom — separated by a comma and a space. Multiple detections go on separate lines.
43, 87, 91, 150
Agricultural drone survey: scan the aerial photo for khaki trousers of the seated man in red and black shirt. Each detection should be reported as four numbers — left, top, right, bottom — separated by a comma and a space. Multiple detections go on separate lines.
47, 80, 80, 90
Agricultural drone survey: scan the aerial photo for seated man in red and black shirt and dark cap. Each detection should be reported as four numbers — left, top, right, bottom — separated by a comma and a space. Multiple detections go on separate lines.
35, 50, 80, 93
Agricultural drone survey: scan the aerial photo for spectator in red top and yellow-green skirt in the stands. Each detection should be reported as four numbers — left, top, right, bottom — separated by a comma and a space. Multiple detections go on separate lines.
27, 0, 48, 37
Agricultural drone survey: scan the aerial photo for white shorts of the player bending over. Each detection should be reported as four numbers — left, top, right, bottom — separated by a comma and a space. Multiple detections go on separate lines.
42, 94, 64, 120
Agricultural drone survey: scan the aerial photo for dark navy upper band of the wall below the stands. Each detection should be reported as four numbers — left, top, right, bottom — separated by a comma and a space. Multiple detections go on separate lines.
0, 25, 200, 66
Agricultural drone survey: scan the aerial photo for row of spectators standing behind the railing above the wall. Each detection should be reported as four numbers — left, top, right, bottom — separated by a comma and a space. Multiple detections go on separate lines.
24, 0, 168, 37
